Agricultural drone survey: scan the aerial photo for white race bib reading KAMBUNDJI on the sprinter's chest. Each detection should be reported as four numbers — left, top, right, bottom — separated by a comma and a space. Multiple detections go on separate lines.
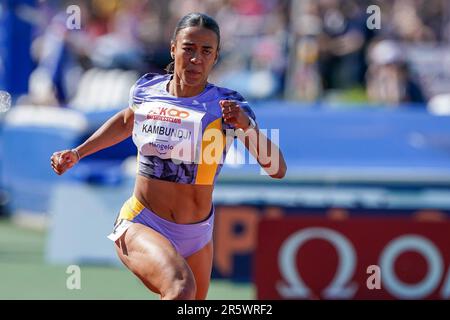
133, 101, 205, 162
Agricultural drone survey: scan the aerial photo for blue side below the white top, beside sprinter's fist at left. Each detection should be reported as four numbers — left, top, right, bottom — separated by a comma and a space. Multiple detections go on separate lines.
2, 126, 79, 213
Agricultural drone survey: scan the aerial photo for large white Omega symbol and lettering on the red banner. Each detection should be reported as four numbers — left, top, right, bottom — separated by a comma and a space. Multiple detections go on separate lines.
276, 227, 450, 299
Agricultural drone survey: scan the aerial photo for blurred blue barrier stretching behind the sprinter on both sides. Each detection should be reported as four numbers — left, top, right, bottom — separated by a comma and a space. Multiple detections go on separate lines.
2, 102, 450, 218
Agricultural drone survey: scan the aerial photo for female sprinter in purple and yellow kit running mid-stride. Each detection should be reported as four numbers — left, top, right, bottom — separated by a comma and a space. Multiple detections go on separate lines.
51, 13, 286, 299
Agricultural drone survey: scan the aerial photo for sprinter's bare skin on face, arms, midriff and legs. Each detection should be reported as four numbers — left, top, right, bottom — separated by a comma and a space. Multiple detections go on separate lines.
51, 23, 286, 299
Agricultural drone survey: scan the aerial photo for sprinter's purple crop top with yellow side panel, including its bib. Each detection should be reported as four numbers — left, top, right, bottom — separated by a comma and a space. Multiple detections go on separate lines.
129, 73, 255, 185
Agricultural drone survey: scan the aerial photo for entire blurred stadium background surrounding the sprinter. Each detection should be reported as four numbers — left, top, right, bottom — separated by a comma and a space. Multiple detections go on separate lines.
0, 0, 450, 299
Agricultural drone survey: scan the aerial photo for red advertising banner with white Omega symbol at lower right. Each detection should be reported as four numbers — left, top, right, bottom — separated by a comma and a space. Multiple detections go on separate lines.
253, 217, 450, 299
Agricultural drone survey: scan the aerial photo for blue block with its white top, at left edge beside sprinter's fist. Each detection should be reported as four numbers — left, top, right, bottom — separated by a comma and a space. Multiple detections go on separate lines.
0, 106, 86, 213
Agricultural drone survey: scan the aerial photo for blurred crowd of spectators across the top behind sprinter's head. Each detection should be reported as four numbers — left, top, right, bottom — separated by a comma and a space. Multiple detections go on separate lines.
10, 0, 450, 105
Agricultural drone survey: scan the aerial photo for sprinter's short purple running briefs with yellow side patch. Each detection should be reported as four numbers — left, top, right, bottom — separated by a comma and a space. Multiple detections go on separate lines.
110, 196, 214, 258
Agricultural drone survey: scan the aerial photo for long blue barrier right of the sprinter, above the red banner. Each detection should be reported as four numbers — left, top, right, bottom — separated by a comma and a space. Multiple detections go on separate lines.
223, 103, 450, 186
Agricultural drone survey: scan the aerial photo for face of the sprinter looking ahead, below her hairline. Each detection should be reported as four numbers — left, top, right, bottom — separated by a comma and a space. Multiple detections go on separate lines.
170, 27, 218, 87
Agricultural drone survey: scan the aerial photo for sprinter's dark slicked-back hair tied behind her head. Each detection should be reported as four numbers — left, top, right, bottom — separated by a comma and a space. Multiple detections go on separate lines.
166, 12, 220, 73
